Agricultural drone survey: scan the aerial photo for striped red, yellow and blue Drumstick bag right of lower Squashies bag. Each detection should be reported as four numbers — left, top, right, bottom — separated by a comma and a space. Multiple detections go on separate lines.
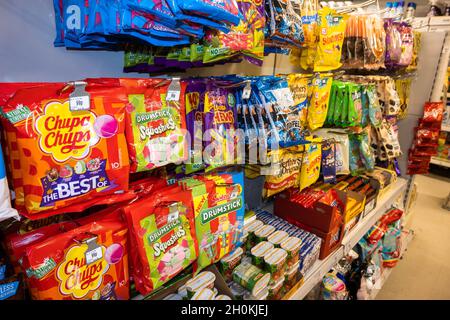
179, 172, 244, 273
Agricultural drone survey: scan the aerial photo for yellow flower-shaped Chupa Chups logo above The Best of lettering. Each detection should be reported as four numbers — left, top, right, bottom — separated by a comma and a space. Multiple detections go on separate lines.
35, 101, 99, 162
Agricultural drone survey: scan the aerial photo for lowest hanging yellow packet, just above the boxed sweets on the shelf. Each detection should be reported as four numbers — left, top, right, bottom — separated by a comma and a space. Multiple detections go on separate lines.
299, 137, 322, 191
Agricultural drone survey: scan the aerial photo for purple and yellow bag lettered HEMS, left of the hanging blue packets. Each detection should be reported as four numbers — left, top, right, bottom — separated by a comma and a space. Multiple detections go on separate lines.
203, 79, 237, 171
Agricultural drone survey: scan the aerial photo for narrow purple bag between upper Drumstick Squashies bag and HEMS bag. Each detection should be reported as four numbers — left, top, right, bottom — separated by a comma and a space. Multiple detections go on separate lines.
185, 79, 206, 174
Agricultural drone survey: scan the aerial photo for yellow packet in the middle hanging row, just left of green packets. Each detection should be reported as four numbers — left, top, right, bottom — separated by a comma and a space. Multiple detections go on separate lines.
307, 74, 332, 130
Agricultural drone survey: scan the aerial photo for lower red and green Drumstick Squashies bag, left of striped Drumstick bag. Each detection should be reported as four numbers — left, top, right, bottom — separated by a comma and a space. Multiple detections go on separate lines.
124, 186, 198, 295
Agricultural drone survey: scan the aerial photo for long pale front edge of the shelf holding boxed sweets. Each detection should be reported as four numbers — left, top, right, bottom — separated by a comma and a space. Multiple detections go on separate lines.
290, 178, 406, 300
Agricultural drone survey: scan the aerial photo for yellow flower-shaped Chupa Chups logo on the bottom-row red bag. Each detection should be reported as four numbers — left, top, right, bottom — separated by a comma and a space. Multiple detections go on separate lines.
56, 244, 109, 299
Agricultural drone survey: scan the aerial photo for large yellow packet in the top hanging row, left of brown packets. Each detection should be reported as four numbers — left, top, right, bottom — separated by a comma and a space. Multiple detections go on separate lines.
314, 7, 347, 72
